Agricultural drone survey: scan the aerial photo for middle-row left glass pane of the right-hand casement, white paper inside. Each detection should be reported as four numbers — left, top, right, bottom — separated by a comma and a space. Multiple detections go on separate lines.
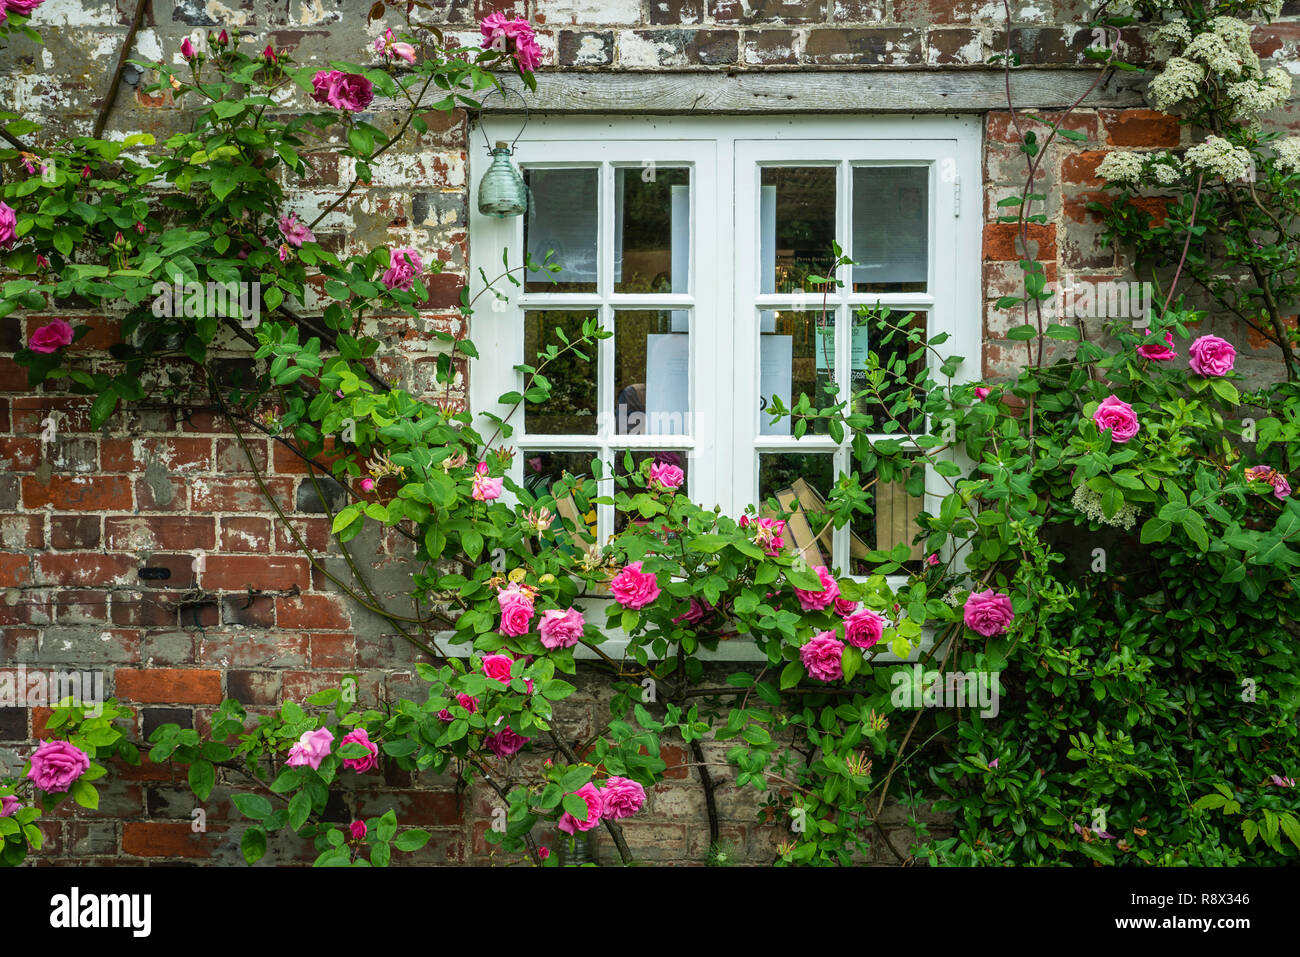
758, 309, 836, 436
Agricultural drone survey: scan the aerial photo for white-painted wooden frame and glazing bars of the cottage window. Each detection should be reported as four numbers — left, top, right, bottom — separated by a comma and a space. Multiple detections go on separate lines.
469, 114, 983, 659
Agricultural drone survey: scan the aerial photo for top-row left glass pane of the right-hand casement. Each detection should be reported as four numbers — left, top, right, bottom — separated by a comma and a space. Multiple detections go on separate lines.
758, 166, 836, 293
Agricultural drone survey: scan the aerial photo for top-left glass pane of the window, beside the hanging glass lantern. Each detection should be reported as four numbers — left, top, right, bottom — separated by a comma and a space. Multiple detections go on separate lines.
524, 168, 601, 293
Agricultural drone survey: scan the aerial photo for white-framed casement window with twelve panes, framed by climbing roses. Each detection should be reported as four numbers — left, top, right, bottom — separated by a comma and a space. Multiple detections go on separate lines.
471, 116, 983, 573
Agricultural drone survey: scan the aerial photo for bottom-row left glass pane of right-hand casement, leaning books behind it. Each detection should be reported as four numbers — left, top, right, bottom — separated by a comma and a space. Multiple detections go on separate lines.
758, 452, 835, 568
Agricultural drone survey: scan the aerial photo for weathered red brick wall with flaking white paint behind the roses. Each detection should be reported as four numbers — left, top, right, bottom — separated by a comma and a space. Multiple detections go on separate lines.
0, 0, 1300, 862
